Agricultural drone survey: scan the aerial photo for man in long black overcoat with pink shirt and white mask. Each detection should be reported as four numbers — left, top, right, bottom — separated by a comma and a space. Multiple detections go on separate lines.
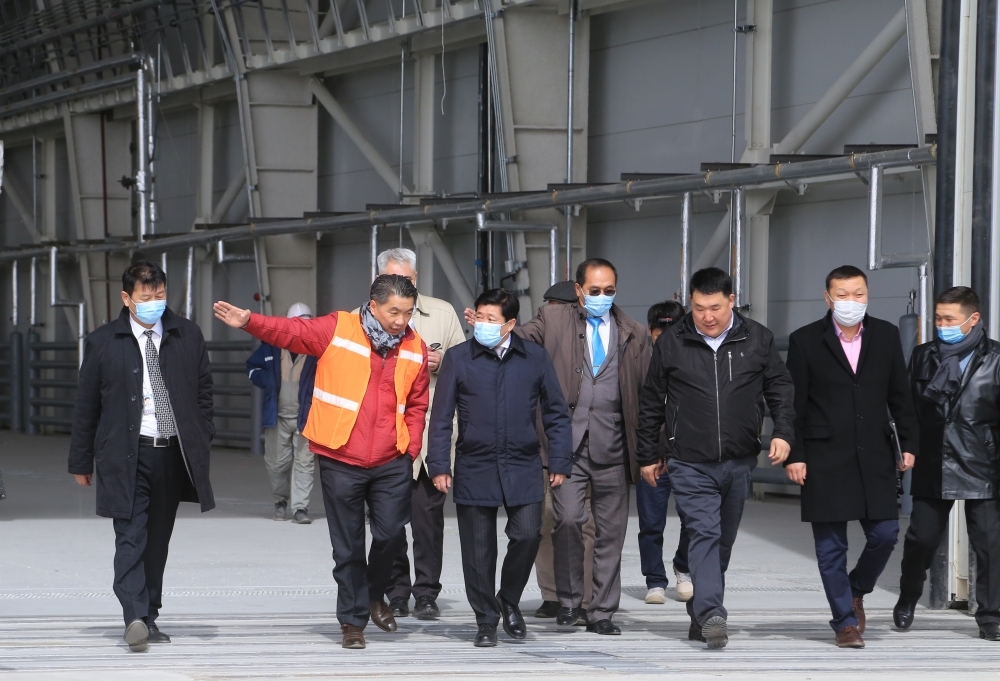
785, 265, 919, 648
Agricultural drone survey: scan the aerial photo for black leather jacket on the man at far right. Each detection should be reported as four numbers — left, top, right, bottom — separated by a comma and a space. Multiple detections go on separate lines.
910, 332, 1000, 499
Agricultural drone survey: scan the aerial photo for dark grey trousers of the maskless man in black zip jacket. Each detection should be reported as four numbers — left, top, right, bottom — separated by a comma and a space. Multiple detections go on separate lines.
667, 456, 757, 626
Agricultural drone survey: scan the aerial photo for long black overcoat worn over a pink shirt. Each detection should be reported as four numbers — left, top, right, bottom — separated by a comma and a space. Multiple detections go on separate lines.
786, 313, 919, 522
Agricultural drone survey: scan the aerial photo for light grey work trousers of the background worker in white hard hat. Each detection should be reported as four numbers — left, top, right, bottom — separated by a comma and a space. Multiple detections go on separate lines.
264, 416, 316, 511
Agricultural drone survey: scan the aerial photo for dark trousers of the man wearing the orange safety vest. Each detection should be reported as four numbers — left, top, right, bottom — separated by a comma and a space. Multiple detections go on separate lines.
319, 455, 413, 627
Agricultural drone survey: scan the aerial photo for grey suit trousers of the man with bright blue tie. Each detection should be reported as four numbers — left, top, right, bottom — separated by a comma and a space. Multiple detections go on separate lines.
552, 440, 629, 623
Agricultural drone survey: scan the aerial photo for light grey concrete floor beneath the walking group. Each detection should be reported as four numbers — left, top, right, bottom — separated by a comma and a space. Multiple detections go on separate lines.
0, 432, 1000, 681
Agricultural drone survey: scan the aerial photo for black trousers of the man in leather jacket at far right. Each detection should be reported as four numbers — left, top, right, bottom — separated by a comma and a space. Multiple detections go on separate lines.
899, 497, 1000, 624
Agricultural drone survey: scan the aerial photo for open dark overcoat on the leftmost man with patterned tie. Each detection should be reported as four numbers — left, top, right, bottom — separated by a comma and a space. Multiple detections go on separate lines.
69, 308, 215, 519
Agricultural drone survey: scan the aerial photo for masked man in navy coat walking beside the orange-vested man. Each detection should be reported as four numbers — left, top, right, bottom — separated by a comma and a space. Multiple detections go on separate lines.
427, 289, 573, 647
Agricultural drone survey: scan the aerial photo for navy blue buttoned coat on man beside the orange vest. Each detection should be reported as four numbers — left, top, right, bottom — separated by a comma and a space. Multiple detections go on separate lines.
427, 335, 573, 507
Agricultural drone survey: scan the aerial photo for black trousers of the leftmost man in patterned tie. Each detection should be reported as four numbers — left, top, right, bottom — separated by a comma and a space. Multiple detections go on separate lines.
114, 445, 187, 624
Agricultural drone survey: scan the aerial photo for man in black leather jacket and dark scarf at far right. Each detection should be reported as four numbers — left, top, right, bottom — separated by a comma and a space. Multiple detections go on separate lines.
892, 286, 1000, 641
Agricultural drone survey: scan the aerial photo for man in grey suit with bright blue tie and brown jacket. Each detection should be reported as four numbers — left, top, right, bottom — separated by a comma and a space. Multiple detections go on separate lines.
514, 258, 650, 635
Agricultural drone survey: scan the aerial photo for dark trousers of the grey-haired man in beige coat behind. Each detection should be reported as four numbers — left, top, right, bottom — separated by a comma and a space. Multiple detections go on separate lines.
386, 466, 448, 600
